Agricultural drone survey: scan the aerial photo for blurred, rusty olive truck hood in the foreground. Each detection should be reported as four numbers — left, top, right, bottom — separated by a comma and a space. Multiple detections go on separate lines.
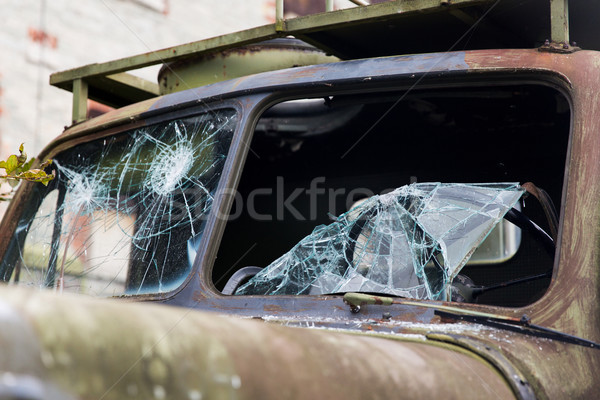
0, 288, 527, 399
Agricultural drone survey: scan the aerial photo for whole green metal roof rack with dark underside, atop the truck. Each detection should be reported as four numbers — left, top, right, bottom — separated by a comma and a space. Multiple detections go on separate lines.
50, 0, 569, 122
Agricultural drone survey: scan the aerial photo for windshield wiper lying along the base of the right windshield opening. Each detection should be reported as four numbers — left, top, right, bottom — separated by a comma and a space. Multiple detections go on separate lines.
344, 293, 600, 349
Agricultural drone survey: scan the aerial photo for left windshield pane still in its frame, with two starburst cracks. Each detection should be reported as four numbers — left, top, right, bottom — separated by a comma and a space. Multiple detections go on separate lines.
0, 110, 237, 296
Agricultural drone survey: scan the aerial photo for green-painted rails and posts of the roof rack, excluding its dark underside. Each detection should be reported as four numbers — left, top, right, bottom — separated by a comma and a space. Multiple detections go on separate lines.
50, 0, 569, 123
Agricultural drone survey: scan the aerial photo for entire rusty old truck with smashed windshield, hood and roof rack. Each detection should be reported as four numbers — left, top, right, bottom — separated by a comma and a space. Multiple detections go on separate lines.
0, 0, 600, 399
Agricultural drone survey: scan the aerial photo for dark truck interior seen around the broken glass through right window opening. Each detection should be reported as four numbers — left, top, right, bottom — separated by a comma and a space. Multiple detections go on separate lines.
212, 81, 571, 307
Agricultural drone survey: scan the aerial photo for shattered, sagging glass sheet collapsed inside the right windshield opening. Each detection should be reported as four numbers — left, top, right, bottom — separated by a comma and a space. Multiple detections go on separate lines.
235, 183, 524, 300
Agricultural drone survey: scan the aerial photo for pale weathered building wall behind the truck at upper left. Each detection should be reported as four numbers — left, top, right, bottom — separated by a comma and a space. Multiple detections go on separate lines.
0, 0, 274, 157
